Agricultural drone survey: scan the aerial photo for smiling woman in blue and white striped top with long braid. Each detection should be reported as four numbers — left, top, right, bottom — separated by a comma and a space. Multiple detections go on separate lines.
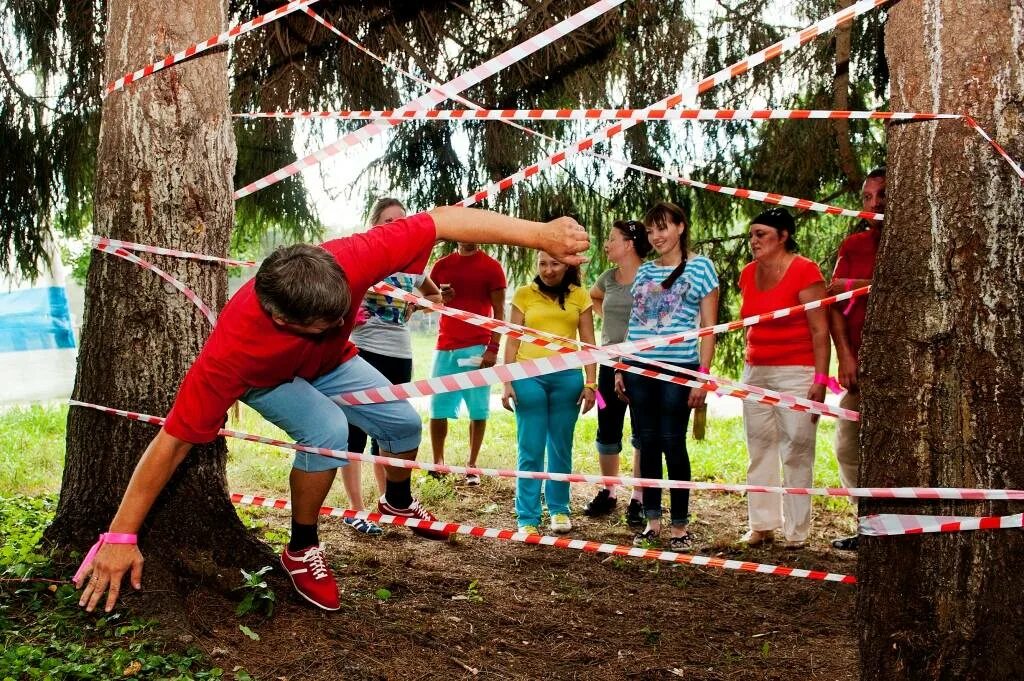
615, 202, 719, 551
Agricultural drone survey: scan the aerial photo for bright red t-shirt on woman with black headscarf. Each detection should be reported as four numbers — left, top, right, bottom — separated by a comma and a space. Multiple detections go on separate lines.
739, 255, 824, 367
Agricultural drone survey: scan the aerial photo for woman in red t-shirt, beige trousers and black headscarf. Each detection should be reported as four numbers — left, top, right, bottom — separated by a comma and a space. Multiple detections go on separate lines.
739, 208, 831, 549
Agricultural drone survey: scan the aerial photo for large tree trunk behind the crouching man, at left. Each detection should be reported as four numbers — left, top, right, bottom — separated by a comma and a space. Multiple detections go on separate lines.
47, 0, 265, 586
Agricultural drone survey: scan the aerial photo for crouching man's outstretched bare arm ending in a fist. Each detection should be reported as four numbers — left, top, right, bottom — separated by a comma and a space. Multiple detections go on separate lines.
430, 206, 590, 265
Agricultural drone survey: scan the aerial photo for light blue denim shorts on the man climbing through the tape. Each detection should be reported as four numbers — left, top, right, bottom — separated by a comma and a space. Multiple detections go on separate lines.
242, 356, 423, 473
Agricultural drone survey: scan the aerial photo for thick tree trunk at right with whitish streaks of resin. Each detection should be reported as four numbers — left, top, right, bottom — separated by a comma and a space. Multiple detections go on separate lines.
857, 0, 1024, 680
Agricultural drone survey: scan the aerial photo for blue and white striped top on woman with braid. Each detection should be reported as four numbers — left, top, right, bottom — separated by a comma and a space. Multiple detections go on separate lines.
627, 255, 718, 365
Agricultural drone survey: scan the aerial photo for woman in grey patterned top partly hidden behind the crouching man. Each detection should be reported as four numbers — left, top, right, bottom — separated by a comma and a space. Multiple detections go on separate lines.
341, 198, 441, 537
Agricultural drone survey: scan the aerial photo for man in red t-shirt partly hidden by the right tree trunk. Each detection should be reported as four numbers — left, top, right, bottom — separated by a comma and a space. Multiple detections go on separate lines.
827, 168, 886, 551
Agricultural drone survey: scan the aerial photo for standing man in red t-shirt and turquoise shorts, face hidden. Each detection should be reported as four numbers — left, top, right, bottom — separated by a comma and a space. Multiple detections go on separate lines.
430, 242, 508, 485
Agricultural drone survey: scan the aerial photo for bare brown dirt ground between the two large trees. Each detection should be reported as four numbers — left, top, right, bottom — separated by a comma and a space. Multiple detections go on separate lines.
144, 479, 857, 681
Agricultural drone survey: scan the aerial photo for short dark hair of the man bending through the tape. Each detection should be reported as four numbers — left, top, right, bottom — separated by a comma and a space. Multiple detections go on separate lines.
256, 244, 352, 325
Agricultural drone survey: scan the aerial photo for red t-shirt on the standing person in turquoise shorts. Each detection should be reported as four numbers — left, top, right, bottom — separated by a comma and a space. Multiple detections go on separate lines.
430, 251, 508, 350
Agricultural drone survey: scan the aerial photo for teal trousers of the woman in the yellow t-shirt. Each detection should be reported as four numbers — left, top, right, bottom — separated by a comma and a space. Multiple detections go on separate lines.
512, 369, 583, 527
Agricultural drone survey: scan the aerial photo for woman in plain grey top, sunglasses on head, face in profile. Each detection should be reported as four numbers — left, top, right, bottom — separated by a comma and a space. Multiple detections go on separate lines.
583, 220, 650, 528
